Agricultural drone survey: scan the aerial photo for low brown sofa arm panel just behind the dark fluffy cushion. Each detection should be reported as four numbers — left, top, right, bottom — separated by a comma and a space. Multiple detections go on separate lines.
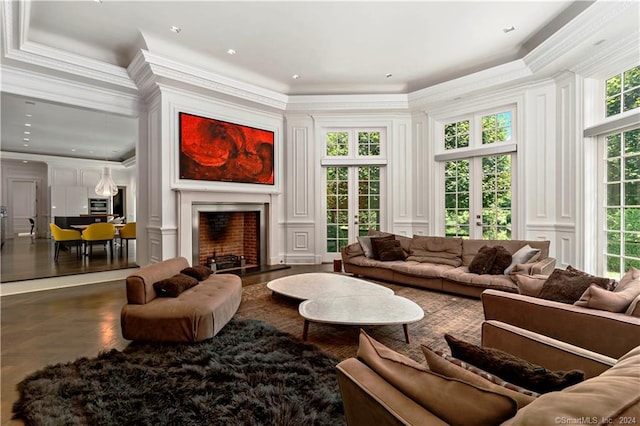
482, 320, 616, 378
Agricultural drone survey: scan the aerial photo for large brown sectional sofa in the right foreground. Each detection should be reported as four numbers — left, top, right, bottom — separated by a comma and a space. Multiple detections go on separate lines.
337, 290, 640, 426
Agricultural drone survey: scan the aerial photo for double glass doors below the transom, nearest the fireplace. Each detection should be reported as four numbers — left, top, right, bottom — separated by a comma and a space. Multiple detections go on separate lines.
323, 165, 383, 261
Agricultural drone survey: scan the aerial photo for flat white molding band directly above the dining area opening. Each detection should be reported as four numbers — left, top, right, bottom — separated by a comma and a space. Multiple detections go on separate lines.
0, 65, 139, 116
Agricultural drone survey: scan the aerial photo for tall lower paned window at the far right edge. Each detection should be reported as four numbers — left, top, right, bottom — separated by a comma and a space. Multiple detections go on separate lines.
604, 129, 640, 276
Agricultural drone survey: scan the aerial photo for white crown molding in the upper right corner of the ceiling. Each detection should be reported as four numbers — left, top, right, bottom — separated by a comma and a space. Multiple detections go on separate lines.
524, 0, 638, 73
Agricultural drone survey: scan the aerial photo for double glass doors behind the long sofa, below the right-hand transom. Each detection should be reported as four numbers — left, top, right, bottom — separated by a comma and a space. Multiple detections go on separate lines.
444, 154, 512, 240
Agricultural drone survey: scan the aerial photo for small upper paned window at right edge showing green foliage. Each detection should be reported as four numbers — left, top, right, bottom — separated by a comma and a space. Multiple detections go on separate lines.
605, 66, 640, 117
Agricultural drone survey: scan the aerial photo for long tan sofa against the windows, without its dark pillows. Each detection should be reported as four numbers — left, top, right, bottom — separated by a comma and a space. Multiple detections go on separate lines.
341, 233, 556, 297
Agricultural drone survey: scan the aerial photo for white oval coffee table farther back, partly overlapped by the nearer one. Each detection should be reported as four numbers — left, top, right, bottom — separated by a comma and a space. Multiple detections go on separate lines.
267, 272, 394, 300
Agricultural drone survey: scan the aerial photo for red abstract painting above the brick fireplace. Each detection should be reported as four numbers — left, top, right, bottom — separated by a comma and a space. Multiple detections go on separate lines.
180, 112, 274, 185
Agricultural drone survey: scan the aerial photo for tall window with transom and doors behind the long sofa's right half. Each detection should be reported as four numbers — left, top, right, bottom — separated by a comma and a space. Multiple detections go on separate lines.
436, 110, 515, 239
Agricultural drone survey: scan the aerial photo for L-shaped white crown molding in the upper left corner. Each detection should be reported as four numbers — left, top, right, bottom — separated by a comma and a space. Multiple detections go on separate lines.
2, 1, 137, 91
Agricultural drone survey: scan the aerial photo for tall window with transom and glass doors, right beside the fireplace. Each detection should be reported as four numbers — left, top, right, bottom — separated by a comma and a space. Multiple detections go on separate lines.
322, 129, 386, 255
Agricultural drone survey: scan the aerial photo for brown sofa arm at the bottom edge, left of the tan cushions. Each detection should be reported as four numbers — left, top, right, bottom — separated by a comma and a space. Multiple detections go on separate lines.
336, 358, 446, 426
